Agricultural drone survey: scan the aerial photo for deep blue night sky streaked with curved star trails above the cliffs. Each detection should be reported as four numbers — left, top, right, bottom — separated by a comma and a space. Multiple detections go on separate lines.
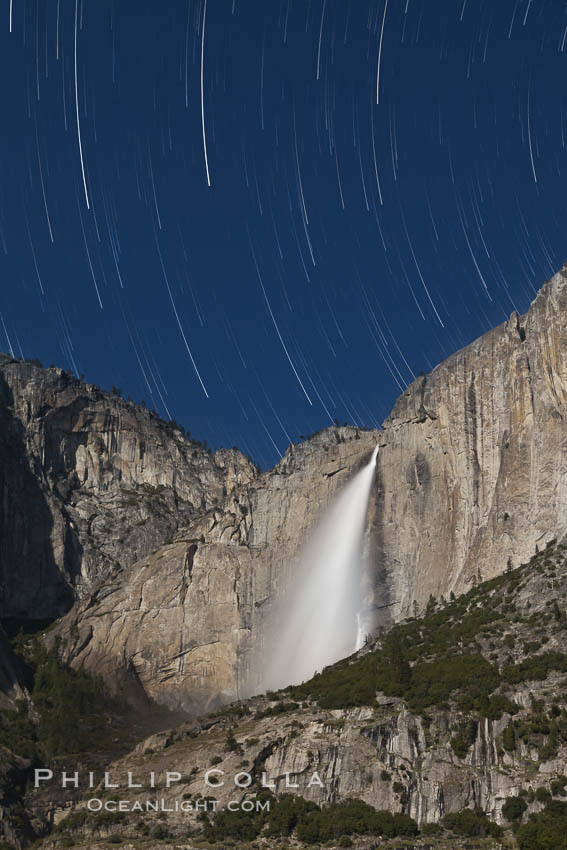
0, 0, 567, 467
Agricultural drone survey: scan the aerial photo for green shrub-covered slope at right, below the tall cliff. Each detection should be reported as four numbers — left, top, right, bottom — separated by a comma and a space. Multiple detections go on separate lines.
286, 543, 567, 719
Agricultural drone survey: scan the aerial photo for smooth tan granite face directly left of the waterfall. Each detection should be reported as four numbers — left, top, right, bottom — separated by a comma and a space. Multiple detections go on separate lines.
53, 428, 382, 711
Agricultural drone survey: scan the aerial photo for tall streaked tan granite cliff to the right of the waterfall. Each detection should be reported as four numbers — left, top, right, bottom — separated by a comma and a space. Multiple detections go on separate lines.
373, 266, 567, 619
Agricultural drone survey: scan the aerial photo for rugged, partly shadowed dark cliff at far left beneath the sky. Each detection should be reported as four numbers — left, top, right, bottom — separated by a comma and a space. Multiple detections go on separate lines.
0, 355, 256, 620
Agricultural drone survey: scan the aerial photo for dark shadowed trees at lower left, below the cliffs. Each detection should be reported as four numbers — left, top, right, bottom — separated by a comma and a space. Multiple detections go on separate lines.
0, 632, 179, 847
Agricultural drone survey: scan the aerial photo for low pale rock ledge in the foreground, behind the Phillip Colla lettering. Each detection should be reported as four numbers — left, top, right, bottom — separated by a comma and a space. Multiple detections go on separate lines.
80, 696, 532, 827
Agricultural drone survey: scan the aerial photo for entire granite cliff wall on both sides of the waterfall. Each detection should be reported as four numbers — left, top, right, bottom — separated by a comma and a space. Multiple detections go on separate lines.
0, 269, 567, 711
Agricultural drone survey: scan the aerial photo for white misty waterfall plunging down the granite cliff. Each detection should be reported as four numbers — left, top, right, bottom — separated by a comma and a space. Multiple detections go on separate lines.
262, 446, 378, 689
